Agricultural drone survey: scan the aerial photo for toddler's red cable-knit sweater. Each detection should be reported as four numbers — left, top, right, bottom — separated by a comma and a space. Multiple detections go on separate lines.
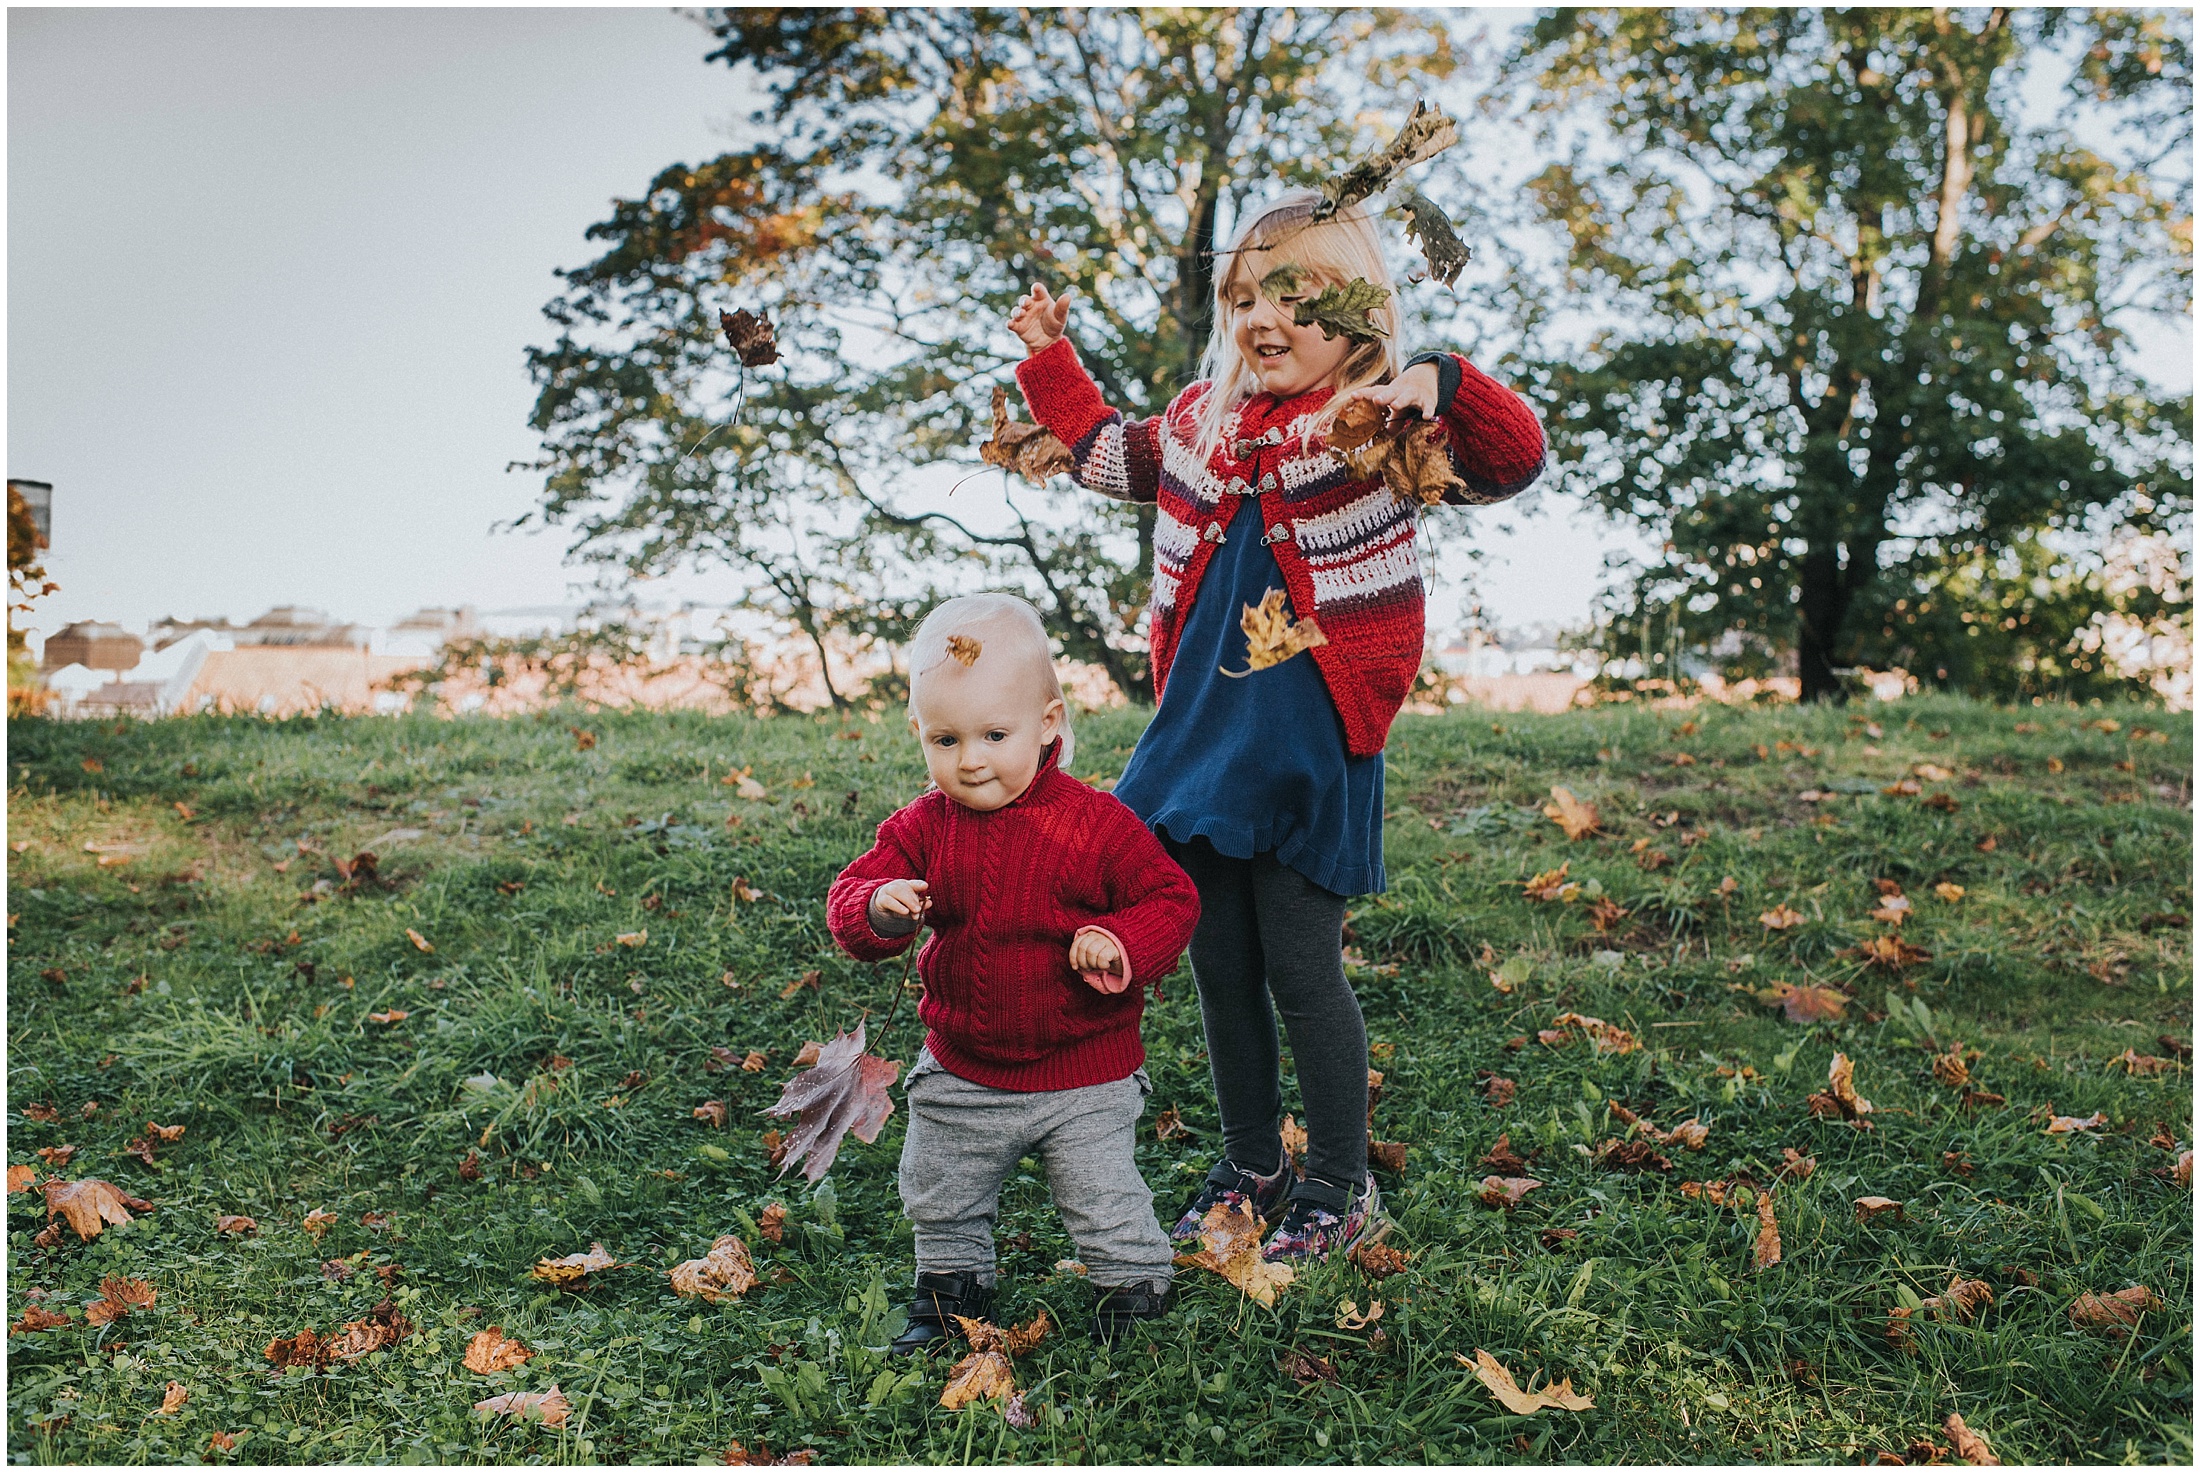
825, 743, 1199, 1093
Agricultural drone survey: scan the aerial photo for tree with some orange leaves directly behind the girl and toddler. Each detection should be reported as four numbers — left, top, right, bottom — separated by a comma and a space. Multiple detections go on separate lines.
524, 9, 1454, 701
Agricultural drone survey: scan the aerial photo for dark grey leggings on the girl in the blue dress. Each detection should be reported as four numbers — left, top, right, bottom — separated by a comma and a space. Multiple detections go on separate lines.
1164, 840, 1368, 1196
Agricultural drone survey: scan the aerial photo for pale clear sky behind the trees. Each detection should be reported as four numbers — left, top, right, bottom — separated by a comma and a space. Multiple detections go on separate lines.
7, 9, 2191, 650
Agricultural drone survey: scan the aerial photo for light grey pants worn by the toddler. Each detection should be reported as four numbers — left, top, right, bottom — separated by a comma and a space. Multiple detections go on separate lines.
902, 1051, 1170, 1286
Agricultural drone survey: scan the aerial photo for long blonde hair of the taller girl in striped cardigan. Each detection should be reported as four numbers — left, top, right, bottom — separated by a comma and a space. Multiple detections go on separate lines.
1192, 189, 1406, 464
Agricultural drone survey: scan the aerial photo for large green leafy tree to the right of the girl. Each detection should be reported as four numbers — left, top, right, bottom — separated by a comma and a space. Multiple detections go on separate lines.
1505, 9, 2191, 699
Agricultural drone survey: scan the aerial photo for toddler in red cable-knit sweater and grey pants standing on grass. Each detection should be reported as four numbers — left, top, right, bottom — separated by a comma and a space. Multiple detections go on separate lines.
827, 594, 1199, 1352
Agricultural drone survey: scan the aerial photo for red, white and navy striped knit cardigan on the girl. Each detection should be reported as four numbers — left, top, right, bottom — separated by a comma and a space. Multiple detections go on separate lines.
1016, 339, 1544, 756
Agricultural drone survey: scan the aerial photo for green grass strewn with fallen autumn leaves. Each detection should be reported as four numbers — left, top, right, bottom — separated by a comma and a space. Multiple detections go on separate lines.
7, 699, 2193, 1462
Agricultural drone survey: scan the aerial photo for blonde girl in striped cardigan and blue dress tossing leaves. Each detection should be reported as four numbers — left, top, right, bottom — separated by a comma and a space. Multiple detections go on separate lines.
1008, 191, 1544, 1260
